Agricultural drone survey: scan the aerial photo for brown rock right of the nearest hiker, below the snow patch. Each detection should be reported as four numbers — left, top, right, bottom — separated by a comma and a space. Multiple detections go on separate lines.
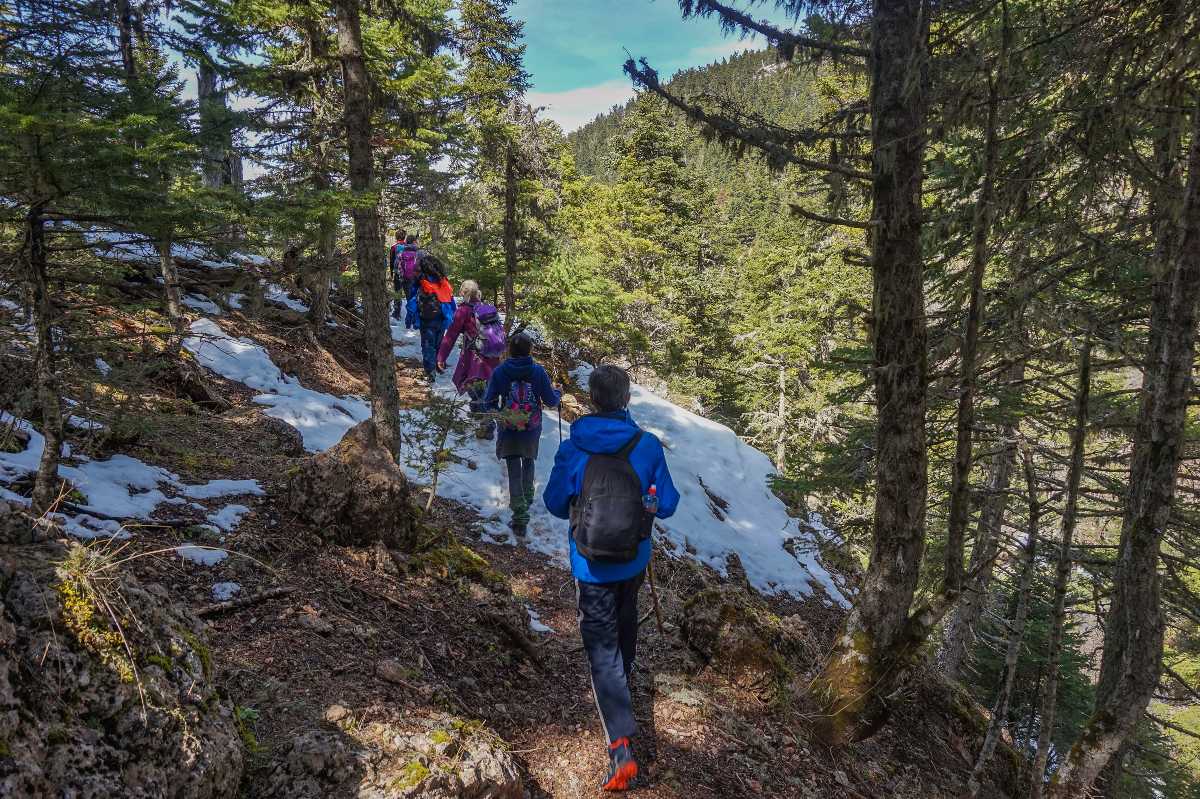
679, 587, 815, 687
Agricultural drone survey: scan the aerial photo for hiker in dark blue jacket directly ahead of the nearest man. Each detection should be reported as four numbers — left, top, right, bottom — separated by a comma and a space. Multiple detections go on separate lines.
482, 332, 560, 536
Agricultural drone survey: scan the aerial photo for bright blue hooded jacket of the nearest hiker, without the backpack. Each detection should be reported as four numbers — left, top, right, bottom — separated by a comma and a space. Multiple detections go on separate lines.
542, 410, 679, 583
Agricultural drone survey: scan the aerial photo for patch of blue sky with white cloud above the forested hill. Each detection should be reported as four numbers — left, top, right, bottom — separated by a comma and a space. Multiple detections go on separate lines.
512, 0, 790, 131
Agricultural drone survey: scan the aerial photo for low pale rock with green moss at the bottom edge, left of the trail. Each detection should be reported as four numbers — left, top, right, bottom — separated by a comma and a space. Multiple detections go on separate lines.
264, 708, 526, 799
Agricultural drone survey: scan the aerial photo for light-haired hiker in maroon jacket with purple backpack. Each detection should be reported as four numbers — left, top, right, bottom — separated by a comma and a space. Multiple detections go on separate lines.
438, 281, 508, 439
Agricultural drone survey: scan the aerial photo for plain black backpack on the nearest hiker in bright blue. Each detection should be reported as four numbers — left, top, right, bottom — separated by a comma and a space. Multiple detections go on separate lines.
571, 431, 654, 563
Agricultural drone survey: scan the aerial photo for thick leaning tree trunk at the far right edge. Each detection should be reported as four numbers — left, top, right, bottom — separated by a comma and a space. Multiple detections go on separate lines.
1050, 108, 1200, 799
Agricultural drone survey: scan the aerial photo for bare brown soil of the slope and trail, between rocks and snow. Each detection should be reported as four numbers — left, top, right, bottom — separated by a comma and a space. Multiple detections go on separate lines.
16, 289, 1004, 799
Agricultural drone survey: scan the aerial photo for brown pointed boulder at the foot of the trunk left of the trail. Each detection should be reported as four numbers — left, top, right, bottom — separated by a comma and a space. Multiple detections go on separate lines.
287, 420, 416, 552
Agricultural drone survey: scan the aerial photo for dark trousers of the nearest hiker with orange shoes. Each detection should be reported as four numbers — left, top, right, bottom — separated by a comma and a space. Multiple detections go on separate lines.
575, 572, 646, 744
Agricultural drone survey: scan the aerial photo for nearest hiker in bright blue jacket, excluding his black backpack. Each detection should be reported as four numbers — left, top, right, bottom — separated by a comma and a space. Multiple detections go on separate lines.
542, 366, 679, 791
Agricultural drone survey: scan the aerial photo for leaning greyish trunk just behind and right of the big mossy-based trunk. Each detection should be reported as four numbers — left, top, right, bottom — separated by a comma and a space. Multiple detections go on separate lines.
938, 419, 1024, 680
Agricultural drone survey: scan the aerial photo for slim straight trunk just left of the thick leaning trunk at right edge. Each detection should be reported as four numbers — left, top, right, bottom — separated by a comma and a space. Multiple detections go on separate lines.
1030, 334, 1092, 799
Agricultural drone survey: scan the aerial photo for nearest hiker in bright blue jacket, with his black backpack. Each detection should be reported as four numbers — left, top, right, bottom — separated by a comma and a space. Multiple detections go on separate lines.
542, 366, 679, 791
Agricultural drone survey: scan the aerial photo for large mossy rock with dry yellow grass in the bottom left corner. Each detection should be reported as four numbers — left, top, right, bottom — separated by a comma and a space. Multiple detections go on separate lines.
0, 503, 242, 799
